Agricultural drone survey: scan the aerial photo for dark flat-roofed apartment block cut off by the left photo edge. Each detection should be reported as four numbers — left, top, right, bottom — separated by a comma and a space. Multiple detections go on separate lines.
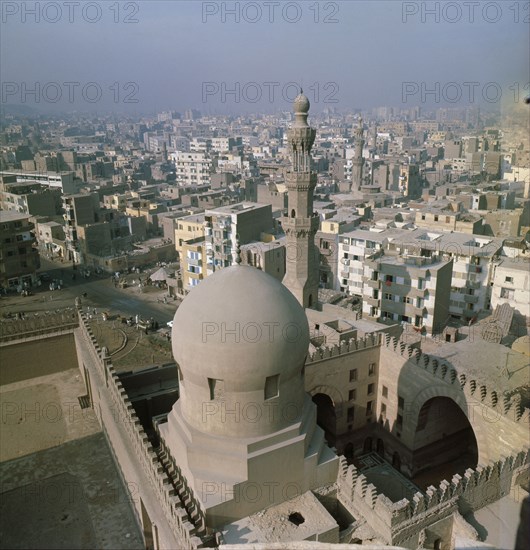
0, 210, 40, 288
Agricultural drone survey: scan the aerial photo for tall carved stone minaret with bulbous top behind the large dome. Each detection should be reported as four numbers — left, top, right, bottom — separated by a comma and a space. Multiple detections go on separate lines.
282, 90, 320, 308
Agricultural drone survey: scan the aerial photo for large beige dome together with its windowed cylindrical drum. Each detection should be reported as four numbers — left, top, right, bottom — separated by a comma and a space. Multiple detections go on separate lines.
172, 266, 309, 436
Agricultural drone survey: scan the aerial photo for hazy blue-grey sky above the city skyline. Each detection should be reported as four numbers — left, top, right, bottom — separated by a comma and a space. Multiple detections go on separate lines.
0, 0, 530, 114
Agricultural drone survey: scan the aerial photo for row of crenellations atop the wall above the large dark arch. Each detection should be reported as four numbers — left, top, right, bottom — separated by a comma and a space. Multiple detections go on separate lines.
382, 334, 530, 425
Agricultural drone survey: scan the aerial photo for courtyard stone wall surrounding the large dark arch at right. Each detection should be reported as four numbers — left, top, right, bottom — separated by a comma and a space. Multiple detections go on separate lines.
378, 337, 530, 469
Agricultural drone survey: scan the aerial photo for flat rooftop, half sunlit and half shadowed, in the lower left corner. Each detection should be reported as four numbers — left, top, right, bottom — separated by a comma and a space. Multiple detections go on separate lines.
0, 368, 144, 550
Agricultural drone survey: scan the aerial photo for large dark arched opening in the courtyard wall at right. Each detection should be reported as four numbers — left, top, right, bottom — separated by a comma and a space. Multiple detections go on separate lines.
412, 397, 478, 488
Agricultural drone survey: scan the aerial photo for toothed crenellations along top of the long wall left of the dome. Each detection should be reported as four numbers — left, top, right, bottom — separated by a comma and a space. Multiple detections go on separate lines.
78, 311, 206, 548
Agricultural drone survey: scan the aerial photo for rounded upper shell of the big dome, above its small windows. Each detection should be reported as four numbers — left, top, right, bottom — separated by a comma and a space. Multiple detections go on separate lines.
172, 266, 309, 391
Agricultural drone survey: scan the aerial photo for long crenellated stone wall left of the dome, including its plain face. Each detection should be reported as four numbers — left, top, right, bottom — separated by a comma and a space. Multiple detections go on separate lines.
75, 312, 204, 548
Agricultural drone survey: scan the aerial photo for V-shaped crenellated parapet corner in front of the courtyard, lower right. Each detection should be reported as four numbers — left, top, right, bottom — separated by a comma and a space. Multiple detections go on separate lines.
337, 450, 530, 544
